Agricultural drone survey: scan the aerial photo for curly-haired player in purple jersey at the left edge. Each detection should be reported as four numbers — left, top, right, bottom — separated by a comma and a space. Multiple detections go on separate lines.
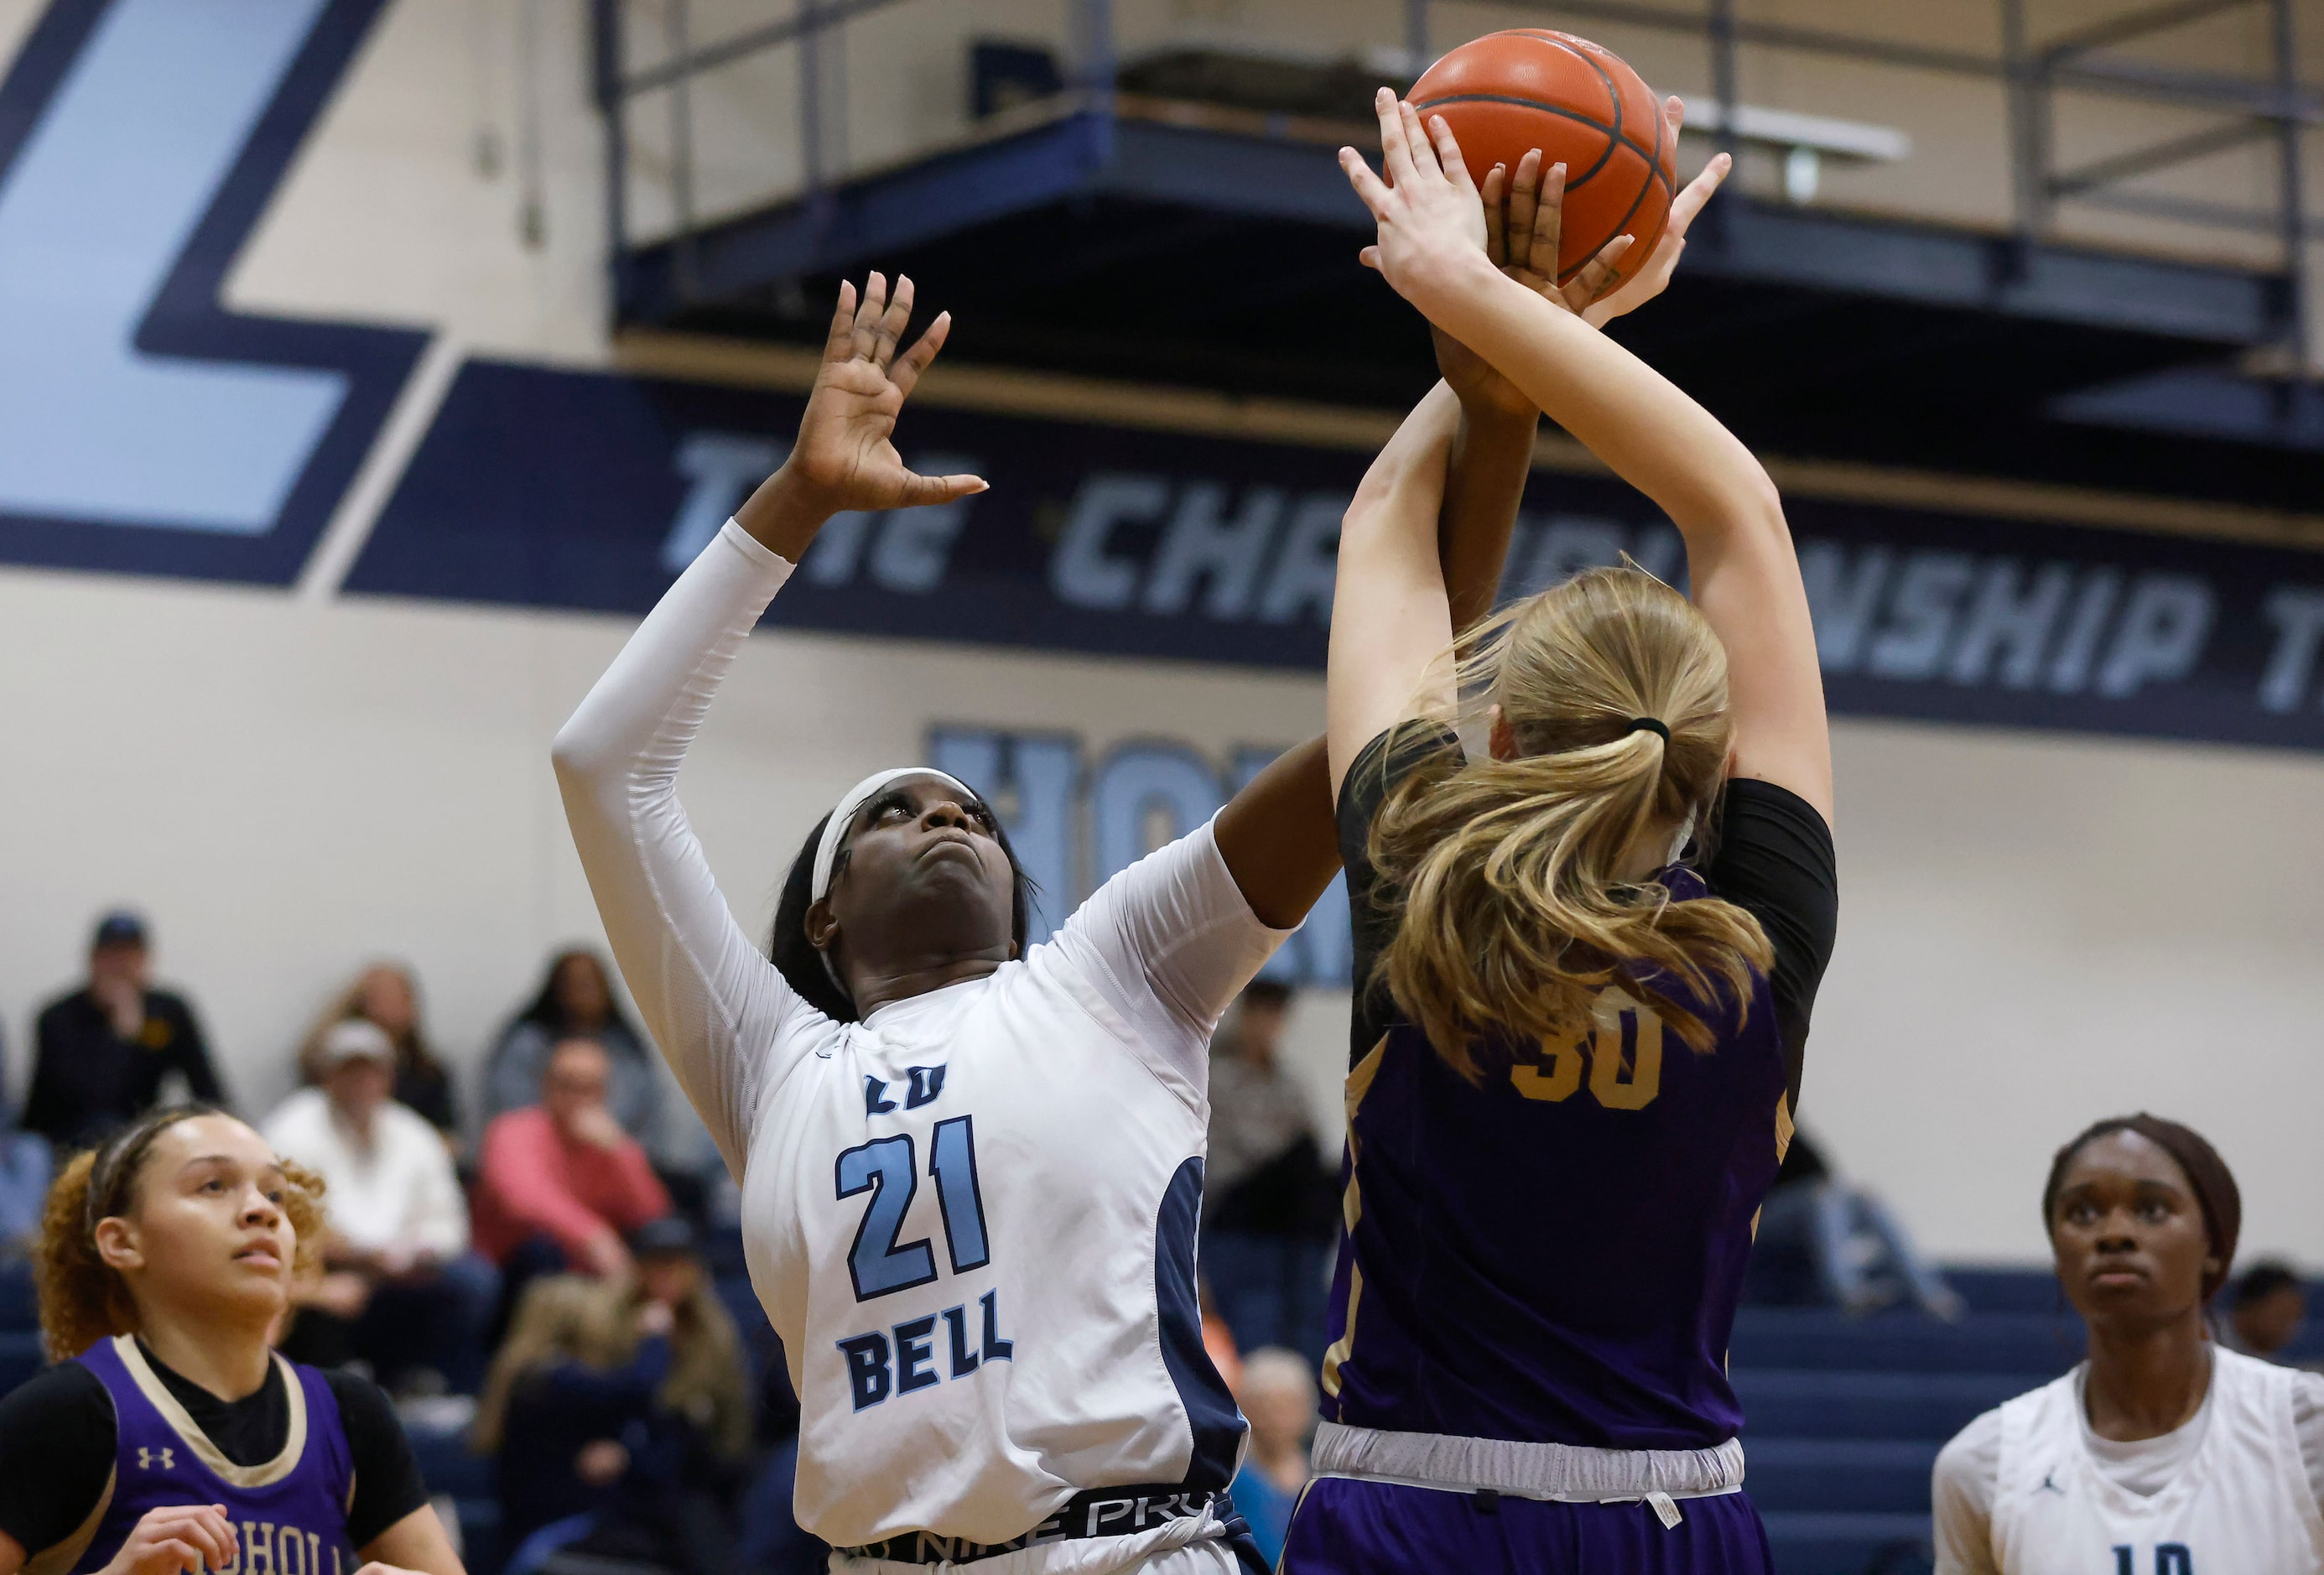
0, 1105, 462, 1575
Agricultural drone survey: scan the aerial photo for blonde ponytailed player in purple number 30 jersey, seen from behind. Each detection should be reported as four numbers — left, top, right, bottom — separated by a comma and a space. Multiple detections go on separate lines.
1283, 93, 1836, 1575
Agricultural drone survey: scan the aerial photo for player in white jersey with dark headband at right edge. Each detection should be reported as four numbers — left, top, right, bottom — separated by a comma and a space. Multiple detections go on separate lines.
1936, 1115, 2324, 1575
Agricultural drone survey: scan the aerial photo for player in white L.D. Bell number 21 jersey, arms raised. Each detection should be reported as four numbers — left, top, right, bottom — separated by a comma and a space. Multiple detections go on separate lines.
555, 274, 1531, 1575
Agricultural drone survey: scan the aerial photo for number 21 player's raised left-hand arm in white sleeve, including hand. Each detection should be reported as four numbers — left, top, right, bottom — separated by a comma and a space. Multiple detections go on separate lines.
553, 274, 983, 1176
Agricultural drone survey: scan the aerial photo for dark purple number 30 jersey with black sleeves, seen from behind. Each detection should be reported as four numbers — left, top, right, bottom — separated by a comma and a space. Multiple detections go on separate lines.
1323, 741, 1833, 1449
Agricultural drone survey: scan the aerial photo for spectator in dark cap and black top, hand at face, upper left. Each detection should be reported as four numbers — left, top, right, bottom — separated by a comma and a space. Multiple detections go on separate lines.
23, 913, 226, 1152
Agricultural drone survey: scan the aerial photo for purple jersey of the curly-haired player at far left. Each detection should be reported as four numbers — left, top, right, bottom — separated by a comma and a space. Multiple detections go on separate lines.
72, 1336, 362, 1575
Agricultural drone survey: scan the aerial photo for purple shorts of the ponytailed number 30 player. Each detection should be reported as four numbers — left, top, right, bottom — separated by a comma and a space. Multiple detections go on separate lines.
1276, 1478, 1775, 1575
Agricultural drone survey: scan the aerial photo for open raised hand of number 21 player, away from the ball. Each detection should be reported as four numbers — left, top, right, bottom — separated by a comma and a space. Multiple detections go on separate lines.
735, 274, 985, 562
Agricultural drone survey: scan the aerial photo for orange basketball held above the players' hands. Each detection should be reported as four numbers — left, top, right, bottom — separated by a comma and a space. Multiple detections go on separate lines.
1411, 28, 1678, 281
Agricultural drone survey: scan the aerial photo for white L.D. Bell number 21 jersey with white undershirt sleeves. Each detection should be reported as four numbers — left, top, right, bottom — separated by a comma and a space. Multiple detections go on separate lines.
555, 522, 1283, 1570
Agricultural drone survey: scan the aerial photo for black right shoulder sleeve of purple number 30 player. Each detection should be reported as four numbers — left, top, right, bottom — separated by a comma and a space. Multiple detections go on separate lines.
1703, 778, 1841, 1115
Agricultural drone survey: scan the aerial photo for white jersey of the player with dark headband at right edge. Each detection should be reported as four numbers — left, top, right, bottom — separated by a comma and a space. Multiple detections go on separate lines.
1936, 1348, 2324, 1575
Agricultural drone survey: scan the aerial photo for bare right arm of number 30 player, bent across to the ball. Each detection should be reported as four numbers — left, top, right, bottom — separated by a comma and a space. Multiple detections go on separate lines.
1334, 88, 1832, 820
